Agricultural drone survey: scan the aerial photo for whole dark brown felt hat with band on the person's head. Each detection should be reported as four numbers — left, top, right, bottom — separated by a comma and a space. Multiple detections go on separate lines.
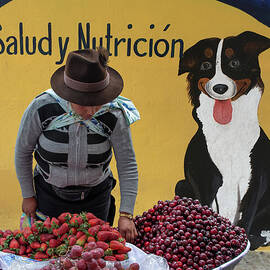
51, 48, 124, 106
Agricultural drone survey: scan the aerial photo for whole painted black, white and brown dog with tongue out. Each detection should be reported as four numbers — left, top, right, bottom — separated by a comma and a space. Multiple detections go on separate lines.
175, 32, 270, 249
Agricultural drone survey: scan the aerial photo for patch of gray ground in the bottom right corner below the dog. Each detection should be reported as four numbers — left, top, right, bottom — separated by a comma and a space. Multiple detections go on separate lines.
234, 251, 270, 270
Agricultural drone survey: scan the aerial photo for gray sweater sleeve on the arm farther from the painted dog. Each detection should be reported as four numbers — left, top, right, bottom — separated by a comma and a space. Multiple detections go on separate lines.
15, 99, 42, 198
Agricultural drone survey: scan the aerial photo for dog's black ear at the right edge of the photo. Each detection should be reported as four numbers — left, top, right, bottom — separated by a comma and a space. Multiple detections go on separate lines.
237, 31, 270, 55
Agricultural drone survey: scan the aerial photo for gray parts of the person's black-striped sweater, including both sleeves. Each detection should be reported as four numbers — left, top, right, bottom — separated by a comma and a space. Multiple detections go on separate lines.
15, 94, 138, 214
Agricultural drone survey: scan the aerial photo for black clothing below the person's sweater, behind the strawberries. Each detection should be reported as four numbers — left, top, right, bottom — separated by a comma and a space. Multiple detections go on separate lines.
34, 174, 116, 225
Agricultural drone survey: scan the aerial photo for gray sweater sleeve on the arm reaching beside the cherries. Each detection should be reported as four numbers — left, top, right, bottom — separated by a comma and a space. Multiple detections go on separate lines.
111, 111, 138, 214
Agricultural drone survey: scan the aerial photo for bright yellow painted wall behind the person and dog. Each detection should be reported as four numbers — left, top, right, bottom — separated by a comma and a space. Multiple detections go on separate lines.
0, 0, 270, 253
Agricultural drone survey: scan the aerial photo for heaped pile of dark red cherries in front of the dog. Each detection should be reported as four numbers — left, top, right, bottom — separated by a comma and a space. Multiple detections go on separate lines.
134, 196, 248, 270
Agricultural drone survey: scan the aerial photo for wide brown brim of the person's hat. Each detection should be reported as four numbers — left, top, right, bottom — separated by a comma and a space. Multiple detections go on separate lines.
51, 66, 124, 106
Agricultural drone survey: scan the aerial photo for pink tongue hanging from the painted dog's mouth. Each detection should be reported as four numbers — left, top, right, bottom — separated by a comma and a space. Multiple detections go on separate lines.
213, 99, 232, 125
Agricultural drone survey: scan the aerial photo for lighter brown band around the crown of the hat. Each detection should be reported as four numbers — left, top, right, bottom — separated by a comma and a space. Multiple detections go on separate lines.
64, 71, 110, 92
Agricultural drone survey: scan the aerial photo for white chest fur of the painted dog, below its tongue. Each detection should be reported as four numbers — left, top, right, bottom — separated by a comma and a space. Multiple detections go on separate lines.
197, 87, 261, 222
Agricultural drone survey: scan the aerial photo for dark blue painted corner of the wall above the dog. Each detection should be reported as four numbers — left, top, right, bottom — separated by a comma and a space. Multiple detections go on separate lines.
217, 0, 270, 27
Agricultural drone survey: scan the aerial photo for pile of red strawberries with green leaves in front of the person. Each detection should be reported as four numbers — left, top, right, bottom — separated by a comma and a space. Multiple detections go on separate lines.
0, 213, 131, 261
